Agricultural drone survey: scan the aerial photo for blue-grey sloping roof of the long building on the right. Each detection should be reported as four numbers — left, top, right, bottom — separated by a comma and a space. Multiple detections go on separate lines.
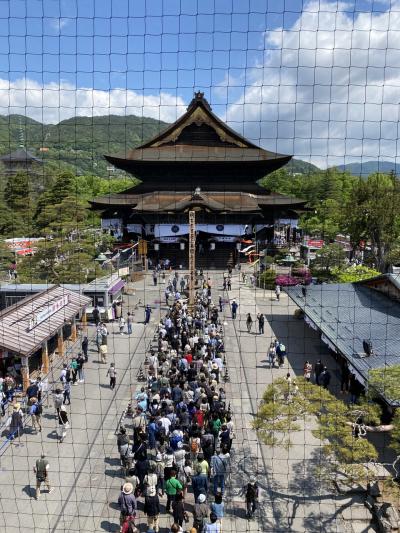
286, 278, 400, 406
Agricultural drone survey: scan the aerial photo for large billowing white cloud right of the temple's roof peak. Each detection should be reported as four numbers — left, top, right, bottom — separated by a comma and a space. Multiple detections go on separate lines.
223, 0, 400, 166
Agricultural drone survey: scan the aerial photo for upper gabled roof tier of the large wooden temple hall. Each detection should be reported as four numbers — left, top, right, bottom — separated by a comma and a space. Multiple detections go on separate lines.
105, 92, 291, 192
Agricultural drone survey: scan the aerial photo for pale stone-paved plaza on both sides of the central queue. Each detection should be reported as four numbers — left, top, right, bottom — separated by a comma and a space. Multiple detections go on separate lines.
0, 272, 373, 533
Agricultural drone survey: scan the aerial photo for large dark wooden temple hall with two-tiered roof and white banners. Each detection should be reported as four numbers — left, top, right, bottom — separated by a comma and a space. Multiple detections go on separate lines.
91, 92, 305, 268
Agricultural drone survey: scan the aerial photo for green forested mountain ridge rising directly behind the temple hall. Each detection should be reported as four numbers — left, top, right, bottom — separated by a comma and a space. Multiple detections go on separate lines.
0, 115, 319, 177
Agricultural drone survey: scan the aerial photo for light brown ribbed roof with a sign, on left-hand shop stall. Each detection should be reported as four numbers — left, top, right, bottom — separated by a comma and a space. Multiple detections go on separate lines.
0, 285, 91, 356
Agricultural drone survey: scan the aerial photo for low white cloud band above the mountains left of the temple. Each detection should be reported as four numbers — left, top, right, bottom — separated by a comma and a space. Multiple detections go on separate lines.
0, 78, 186, 124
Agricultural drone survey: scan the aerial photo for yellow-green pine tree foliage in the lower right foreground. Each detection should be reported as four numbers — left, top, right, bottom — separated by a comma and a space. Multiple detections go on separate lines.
253, 378, 381, 472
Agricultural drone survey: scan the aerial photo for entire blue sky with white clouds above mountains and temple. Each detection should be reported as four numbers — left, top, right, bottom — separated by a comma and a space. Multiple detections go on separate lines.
0, 0, 400, 166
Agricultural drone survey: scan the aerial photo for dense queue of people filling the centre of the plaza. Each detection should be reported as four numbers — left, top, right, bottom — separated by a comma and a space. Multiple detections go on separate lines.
113, 276, 258, 533
